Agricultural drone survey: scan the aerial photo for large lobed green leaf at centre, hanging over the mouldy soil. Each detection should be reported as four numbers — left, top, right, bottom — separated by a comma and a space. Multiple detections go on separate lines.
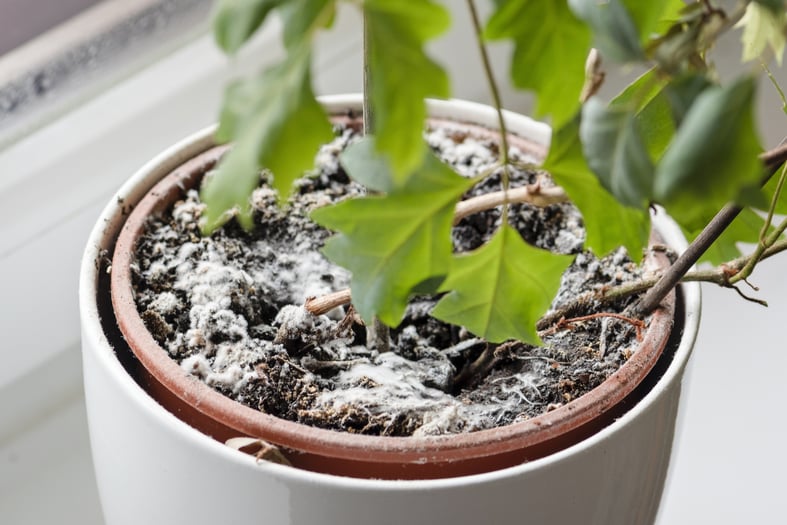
312, 153, 473, 326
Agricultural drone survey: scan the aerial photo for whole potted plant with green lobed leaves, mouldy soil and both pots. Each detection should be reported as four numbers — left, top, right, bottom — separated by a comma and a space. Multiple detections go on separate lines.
81, 0, 784, 523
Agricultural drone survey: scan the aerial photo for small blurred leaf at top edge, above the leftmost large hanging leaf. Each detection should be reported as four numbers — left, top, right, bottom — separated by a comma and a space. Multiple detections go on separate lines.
213, 0, 284, 53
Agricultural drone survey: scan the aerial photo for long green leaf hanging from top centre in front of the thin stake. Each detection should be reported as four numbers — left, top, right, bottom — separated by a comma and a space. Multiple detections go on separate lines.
363, 0, 451, 179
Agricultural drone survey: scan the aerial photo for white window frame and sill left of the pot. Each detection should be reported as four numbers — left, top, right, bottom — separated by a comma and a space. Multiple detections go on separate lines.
0, 11, 361, 525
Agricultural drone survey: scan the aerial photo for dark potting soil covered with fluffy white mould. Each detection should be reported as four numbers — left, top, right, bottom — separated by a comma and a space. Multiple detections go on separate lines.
134, 121, 642, 436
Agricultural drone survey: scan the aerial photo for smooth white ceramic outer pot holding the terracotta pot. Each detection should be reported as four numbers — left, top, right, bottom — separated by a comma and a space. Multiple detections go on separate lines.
79, 96, 700, 525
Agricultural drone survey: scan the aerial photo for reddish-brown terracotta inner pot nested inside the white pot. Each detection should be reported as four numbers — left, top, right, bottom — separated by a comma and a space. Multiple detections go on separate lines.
111, 117, 675, 479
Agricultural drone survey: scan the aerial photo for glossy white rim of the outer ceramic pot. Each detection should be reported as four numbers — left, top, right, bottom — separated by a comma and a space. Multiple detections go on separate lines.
79, 111, 701, 491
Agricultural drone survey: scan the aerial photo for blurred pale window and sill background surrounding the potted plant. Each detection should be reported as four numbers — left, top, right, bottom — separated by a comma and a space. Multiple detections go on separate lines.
0, 0, 787, 525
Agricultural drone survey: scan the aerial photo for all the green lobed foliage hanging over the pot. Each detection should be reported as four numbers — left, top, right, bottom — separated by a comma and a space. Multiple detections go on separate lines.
202, 0, 787, 343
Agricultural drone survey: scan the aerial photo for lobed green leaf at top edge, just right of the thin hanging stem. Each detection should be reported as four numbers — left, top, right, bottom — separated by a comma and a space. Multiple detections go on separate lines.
485, 0, 591, 126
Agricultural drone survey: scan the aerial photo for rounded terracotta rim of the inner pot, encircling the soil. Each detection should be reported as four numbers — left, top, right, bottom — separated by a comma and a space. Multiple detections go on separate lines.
107, 100, 674, 468
